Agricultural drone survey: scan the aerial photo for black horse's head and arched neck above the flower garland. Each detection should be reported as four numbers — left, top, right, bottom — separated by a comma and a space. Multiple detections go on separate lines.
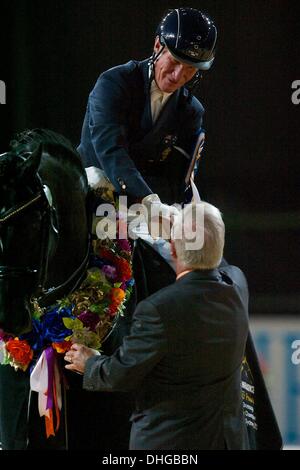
0, 130, 87, 334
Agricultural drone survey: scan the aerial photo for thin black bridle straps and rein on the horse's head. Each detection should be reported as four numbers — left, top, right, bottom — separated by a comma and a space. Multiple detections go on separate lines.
0, 181, 90, 306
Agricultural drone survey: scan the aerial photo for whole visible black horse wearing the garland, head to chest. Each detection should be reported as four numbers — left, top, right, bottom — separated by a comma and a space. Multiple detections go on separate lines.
0, 129, 129, 449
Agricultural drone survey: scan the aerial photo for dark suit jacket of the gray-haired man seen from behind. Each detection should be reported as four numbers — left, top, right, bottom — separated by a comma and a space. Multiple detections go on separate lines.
83, 266, 248, 450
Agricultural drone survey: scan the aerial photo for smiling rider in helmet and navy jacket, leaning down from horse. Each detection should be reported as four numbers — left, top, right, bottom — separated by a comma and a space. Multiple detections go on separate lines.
78, 8, 217, 204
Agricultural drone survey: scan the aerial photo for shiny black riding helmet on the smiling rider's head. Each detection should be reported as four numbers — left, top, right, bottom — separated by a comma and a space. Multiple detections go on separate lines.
156, 8, 217, 71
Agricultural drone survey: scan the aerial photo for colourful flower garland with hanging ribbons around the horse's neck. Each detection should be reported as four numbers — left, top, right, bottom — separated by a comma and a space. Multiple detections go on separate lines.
0, 239, 134, 436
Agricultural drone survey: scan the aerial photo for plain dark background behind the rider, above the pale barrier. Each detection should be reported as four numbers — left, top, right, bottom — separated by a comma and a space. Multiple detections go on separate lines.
0, 0, 300, 314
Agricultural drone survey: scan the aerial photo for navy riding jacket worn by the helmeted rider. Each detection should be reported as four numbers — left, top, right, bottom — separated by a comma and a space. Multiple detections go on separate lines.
78, 60, 204, 203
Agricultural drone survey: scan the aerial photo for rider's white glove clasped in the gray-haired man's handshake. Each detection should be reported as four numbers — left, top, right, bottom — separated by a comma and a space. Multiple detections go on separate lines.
142, 194, 179, 240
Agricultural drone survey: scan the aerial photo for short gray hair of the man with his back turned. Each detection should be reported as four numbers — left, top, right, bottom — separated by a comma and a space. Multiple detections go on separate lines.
172, 202, 225, 270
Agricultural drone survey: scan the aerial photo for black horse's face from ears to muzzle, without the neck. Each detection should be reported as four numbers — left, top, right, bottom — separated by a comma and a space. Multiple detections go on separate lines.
0, 144, 46, 332
